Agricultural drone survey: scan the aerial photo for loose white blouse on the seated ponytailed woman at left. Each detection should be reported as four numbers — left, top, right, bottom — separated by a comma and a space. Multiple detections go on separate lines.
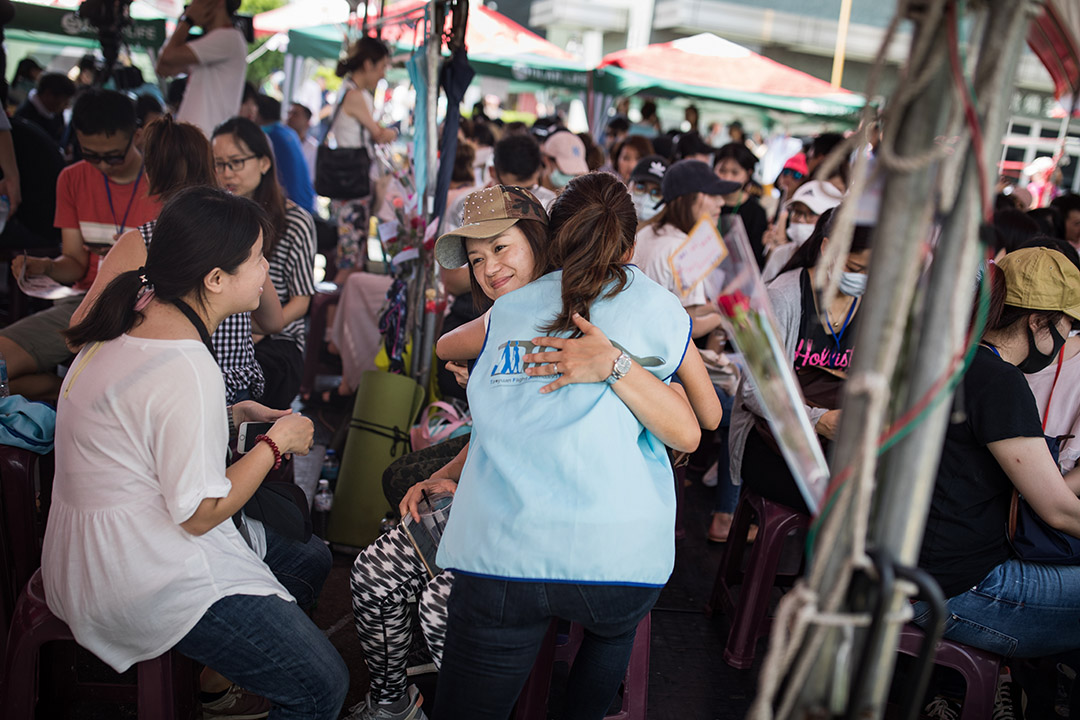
41, 335, 293, 671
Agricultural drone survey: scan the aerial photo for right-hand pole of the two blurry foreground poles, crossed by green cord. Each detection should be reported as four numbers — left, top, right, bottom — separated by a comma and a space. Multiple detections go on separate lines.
853, 0, 1028, 717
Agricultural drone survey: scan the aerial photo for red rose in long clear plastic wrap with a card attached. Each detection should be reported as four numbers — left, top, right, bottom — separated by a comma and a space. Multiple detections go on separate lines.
670, 213, 829, 513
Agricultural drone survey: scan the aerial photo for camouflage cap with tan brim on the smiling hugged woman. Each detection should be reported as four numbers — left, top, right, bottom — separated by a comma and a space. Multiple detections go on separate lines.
435, 185, 548, 270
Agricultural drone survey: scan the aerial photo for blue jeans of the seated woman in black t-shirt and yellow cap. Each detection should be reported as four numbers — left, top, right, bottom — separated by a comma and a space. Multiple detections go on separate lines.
914, 559, 1080, 657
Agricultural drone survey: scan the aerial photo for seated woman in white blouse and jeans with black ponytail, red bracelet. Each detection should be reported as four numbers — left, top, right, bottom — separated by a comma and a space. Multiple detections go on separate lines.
42, 188, 348, 720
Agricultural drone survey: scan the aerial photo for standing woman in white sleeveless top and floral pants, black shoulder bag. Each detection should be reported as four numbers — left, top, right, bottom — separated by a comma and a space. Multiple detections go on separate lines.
329, 36, 397, 284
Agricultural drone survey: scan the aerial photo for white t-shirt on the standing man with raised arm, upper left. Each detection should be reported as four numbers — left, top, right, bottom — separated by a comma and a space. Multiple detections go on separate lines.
176, 27, 247, 137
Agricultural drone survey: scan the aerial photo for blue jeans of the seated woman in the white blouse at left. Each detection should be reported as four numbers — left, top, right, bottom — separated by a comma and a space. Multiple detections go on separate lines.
176, 595, 349, 720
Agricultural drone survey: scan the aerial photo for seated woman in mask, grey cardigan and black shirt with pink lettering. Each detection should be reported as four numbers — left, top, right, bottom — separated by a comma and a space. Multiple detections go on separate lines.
729, 210, 872, 513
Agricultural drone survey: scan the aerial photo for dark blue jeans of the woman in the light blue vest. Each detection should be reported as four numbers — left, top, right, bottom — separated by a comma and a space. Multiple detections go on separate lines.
434, 573, 660, 720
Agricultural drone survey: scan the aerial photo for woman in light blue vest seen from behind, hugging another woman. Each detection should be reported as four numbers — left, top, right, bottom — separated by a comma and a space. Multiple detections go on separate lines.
436, 173, 718, 718
